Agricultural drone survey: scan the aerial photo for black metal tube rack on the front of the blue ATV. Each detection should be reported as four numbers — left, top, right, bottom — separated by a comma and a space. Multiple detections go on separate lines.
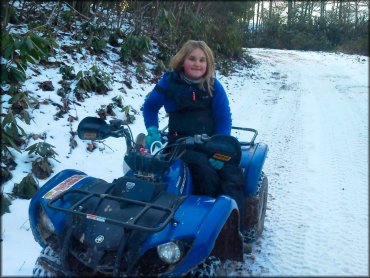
47, 189, 183, 232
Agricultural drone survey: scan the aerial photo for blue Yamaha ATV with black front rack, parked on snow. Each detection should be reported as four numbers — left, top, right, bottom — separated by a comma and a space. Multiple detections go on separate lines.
29, 117, 268, 277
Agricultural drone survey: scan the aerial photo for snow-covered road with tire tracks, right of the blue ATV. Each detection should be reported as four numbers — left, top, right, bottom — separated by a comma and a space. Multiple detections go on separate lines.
223, 49, 369, 276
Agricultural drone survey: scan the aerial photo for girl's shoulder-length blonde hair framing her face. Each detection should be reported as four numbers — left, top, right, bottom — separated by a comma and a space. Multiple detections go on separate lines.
170, 40, 215, 96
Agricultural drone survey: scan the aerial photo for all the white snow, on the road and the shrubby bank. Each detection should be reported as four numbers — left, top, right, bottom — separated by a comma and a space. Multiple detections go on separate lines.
1, 49, 369, 276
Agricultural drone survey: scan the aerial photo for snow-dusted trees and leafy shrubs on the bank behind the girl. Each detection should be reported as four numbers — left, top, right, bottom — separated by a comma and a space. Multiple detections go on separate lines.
0, 0, 369, 213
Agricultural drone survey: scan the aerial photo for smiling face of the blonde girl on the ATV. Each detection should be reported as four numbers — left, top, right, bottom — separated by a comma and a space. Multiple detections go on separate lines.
184, 48, 207, 79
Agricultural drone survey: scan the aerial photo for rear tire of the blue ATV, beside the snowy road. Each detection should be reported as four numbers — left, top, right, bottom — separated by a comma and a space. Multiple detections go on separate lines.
243, 172, 268, 243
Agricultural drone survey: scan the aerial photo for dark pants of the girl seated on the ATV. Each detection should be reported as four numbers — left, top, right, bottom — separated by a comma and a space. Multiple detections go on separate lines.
181, 150, 245, 231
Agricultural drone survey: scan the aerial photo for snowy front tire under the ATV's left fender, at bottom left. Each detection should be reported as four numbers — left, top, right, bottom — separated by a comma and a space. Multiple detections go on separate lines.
32, 246, 61, 277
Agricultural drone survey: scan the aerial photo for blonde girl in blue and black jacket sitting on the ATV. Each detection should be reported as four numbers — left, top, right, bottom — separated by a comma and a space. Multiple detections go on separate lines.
143, 40, 244, 230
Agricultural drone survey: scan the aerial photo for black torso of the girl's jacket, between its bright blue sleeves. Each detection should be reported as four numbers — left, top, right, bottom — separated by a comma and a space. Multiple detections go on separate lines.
156, 72, 214, 141
